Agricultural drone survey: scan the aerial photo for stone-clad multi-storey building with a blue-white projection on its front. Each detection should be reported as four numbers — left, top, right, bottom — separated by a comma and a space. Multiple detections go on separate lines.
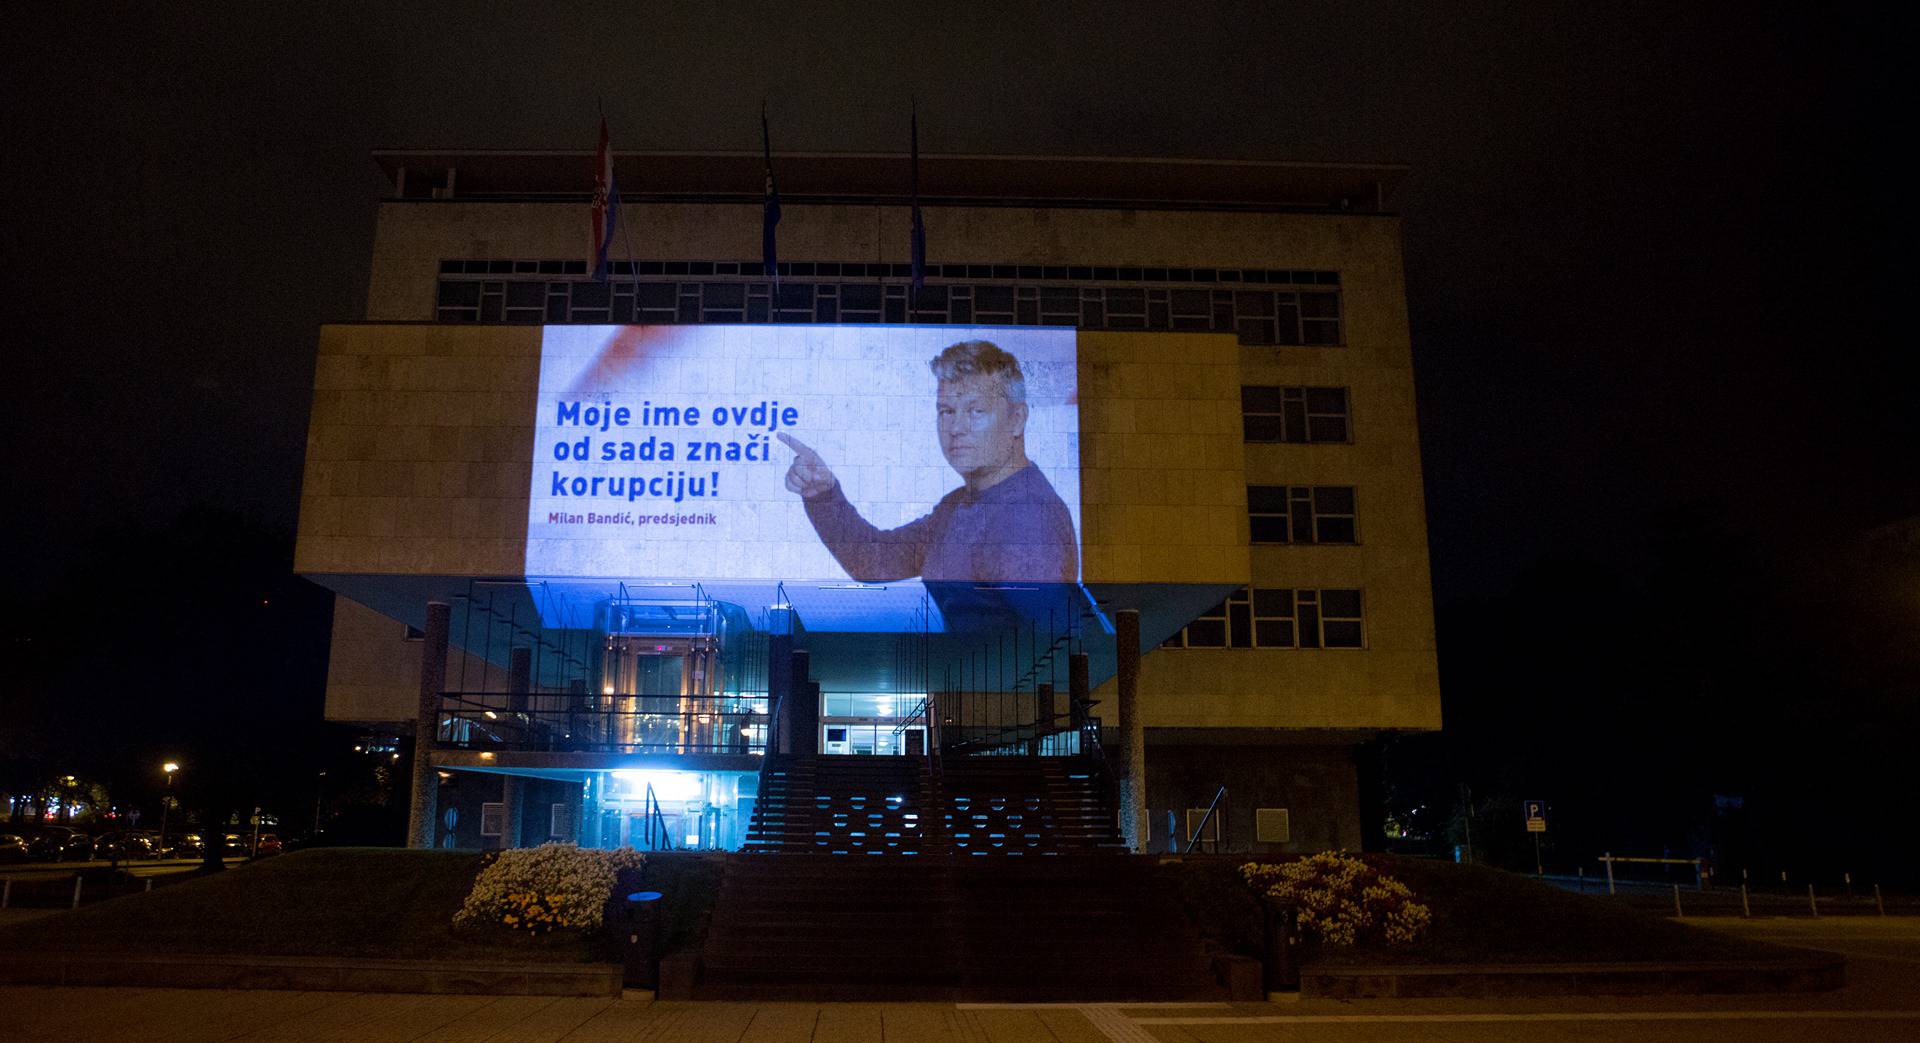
296, 152, 1440, 851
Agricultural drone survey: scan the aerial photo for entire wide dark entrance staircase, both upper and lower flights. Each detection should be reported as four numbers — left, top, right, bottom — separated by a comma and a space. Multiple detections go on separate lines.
695, 757, 1225, 1003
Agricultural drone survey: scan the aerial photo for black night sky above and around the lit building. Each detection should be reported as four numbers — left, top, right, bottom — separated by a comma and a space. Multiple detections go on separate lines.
0, 0, 1920, 603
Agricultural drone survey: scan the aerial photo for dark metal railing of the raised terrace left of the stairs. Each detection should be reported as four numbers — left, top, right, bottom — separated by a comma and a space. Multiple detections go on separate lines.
438, 691, 770, 753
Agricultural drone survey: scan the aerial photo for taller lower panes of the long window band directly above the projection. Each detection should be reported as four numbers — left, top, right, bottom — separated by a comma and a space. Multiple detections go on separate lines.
438, 277, 1340, 346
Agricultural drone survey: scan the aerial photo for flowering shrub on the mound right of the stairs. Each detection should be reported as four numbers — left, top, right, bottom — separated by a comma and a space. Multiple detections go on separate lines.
1240, 851, 1432, 945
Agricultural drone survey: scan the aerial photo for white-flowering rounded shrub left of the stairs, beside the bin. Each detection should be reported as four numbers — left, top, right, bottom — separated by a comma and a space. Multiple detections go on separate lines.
453, 843, 645, 934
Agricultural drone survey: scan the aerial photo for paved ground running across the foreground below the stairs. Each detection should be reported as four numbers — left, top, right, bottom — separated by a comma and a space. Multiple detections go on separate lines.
0, 918, 1920, 1043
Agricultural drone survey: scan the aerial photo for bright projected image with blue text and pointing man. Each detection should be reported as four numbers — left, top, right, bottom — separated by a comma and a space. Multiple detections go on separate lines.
526, 327, 1081, 626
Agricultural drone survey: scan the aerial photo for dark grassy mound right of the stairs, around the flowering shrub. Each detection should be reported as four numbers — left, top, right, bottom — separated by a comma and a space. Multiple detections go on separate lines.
1179, 855, 1797, 966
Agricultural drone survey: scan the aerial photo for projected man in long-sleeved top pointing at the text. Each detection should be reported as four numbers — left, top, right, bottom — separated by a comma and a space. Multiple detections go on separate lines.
780, 340, 1079, 584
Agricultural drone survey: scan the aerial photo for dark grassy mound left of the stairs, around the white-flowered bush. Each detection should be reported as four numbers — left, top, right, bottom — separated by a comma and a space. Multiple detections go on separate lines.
0, 847, 593, 962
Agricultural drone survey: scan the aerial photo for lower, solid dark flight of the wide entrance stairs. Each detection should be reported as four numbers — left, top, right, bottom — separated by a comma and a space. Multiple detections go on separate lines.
693, 855, 1227, 1003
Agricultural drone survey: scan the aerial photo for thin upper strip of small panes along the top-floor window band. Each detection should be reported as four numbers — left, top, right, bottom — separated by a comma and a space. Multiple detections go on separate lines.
440, 261, 1340, 286
